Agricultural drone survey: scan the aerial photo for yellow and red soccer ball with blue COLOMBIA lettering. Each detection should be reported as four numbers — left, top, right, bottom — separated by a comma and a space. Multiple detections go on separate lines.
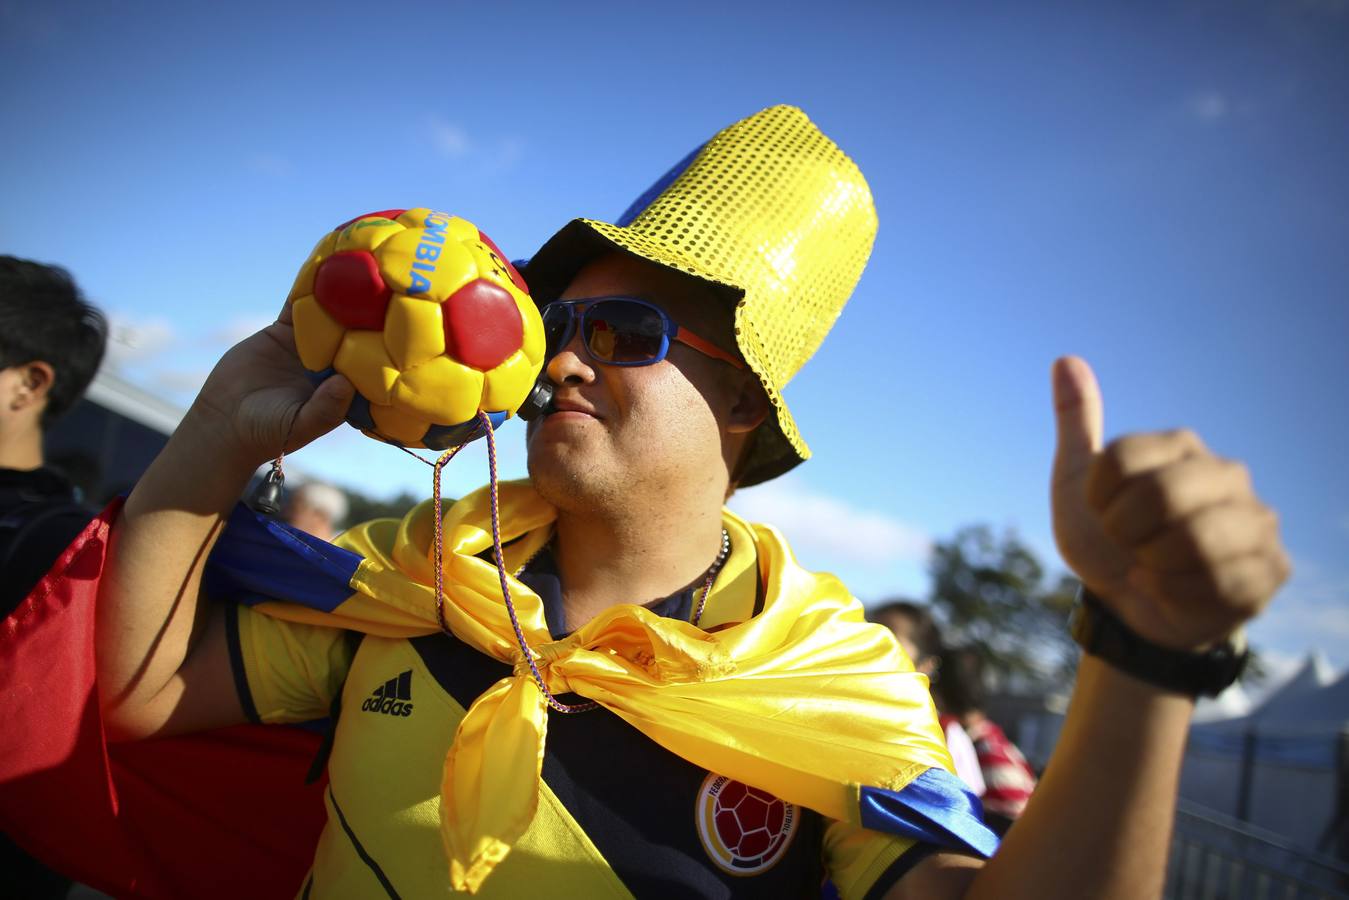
289, 208, 544, 449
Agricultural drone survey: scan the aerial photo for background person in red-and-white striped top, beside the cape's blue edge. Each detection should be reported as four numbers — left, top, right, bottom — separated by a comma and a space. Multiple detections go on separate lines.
932, 646, 1035, 837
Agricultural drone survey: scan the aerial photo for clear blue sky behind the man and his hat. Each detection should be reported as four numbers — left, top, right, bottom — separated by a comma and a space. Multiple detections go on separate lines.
0, 0, 1349, 674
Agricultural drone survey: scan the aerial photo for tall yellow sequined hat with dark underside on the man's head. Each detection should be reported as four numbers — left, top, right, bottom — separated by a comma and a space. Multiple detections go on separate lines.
525, 107, 876, 486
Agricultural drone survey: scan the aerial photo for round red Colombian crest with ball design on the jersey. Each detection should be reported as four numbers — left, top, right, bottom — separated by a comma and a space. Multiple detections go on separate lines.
695, 773, 801, 876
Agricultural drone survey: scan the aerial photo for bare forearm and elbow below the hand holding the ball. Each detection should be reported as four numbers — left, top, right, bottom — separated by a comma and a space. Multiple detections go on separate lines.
96, 412, 255, 735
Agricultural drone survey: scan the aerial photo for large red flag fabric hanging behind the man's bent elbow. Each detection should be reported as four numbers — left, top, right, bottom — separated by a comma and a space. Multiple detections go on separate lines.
0, 501, 325, 900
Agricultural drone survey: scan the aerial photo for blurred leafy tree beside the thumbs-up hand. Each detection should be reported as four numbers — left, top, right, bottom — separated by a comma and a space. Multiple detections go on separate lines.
931, 525, 1078, 690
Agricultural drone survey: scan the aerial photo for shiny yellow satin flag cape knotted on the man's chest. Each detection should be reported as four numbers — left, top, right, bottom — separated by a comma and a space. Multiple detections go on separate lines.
258, 482, 951, 892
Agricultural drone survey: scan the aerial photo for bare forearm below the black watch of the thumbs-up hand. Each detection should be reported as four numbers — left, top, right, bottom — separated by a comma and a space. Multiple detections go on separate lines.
967, 656, 1194, 900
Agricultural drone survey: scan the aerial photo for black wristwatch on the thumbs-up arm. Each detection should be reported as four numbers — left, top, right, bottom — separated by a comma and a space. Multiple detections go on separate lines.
1068, 586, 1251, 696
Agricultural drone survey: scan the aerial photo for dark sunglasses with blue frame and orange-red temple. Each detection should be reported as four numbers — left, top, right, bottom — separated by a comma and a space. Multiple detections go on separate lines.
542, 297, 745, 368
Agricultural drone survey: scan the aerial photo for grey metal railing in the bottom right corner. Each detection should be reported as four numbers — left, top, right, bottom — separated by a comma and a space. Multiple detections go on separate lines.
1164, 800, 1349, 900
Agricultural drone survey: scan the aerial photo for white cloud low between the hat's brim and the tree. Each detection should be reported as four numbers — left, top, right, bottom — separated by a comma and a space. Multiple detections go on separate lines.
730, 475, 932, 565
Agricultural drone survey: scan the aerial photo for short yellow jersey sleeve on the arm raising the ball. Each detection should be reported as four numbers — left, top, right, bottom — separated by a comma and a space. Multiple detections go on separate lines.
227, 606, 356, 722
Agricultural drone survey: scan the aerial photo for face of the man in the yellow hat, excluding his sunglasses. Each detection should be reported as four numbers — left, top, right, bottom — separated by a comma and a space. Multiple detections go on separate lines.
526, 254, 753, 513
